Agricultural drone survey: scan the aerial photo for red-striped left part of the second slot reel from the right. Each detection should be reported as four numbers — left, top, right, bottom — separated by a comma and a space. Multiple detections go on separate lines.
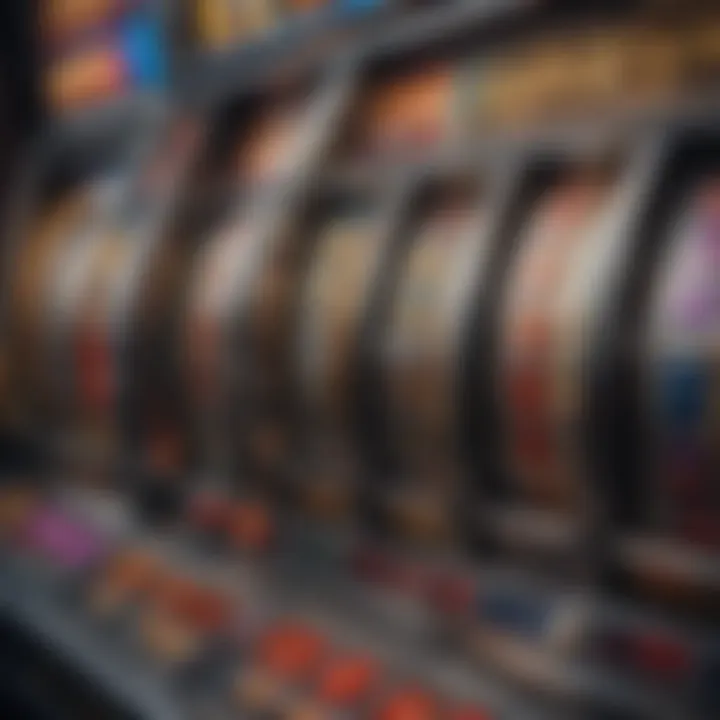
500, 167, 608, 544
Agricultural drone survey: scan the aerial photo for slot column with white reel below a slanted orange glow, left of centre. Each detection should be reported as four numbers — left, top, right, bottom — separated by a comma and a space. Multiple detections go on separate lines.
177, 73, 352, 516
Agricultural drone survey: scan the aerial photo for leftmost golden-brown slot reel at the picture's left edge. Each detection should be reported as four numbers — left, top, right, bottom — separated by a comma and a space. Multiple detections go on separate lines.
1, 117, 155, 470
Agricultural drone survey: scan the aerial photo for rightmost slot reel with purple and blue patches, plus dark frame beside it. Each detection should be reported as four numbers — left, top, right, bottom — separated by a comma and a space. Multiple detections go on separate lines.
596, 128, 719, 616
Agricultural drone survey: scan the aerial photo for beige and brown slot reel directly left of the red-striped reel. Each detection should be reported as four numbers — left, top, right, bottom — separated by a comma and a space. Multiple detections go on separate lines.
376, 177, 489, 544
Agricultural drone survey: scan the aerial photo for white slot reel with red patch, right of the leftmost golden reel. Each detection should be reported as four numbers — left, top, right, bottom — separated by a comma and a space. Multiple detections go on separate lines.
38, 115, 201, 481
